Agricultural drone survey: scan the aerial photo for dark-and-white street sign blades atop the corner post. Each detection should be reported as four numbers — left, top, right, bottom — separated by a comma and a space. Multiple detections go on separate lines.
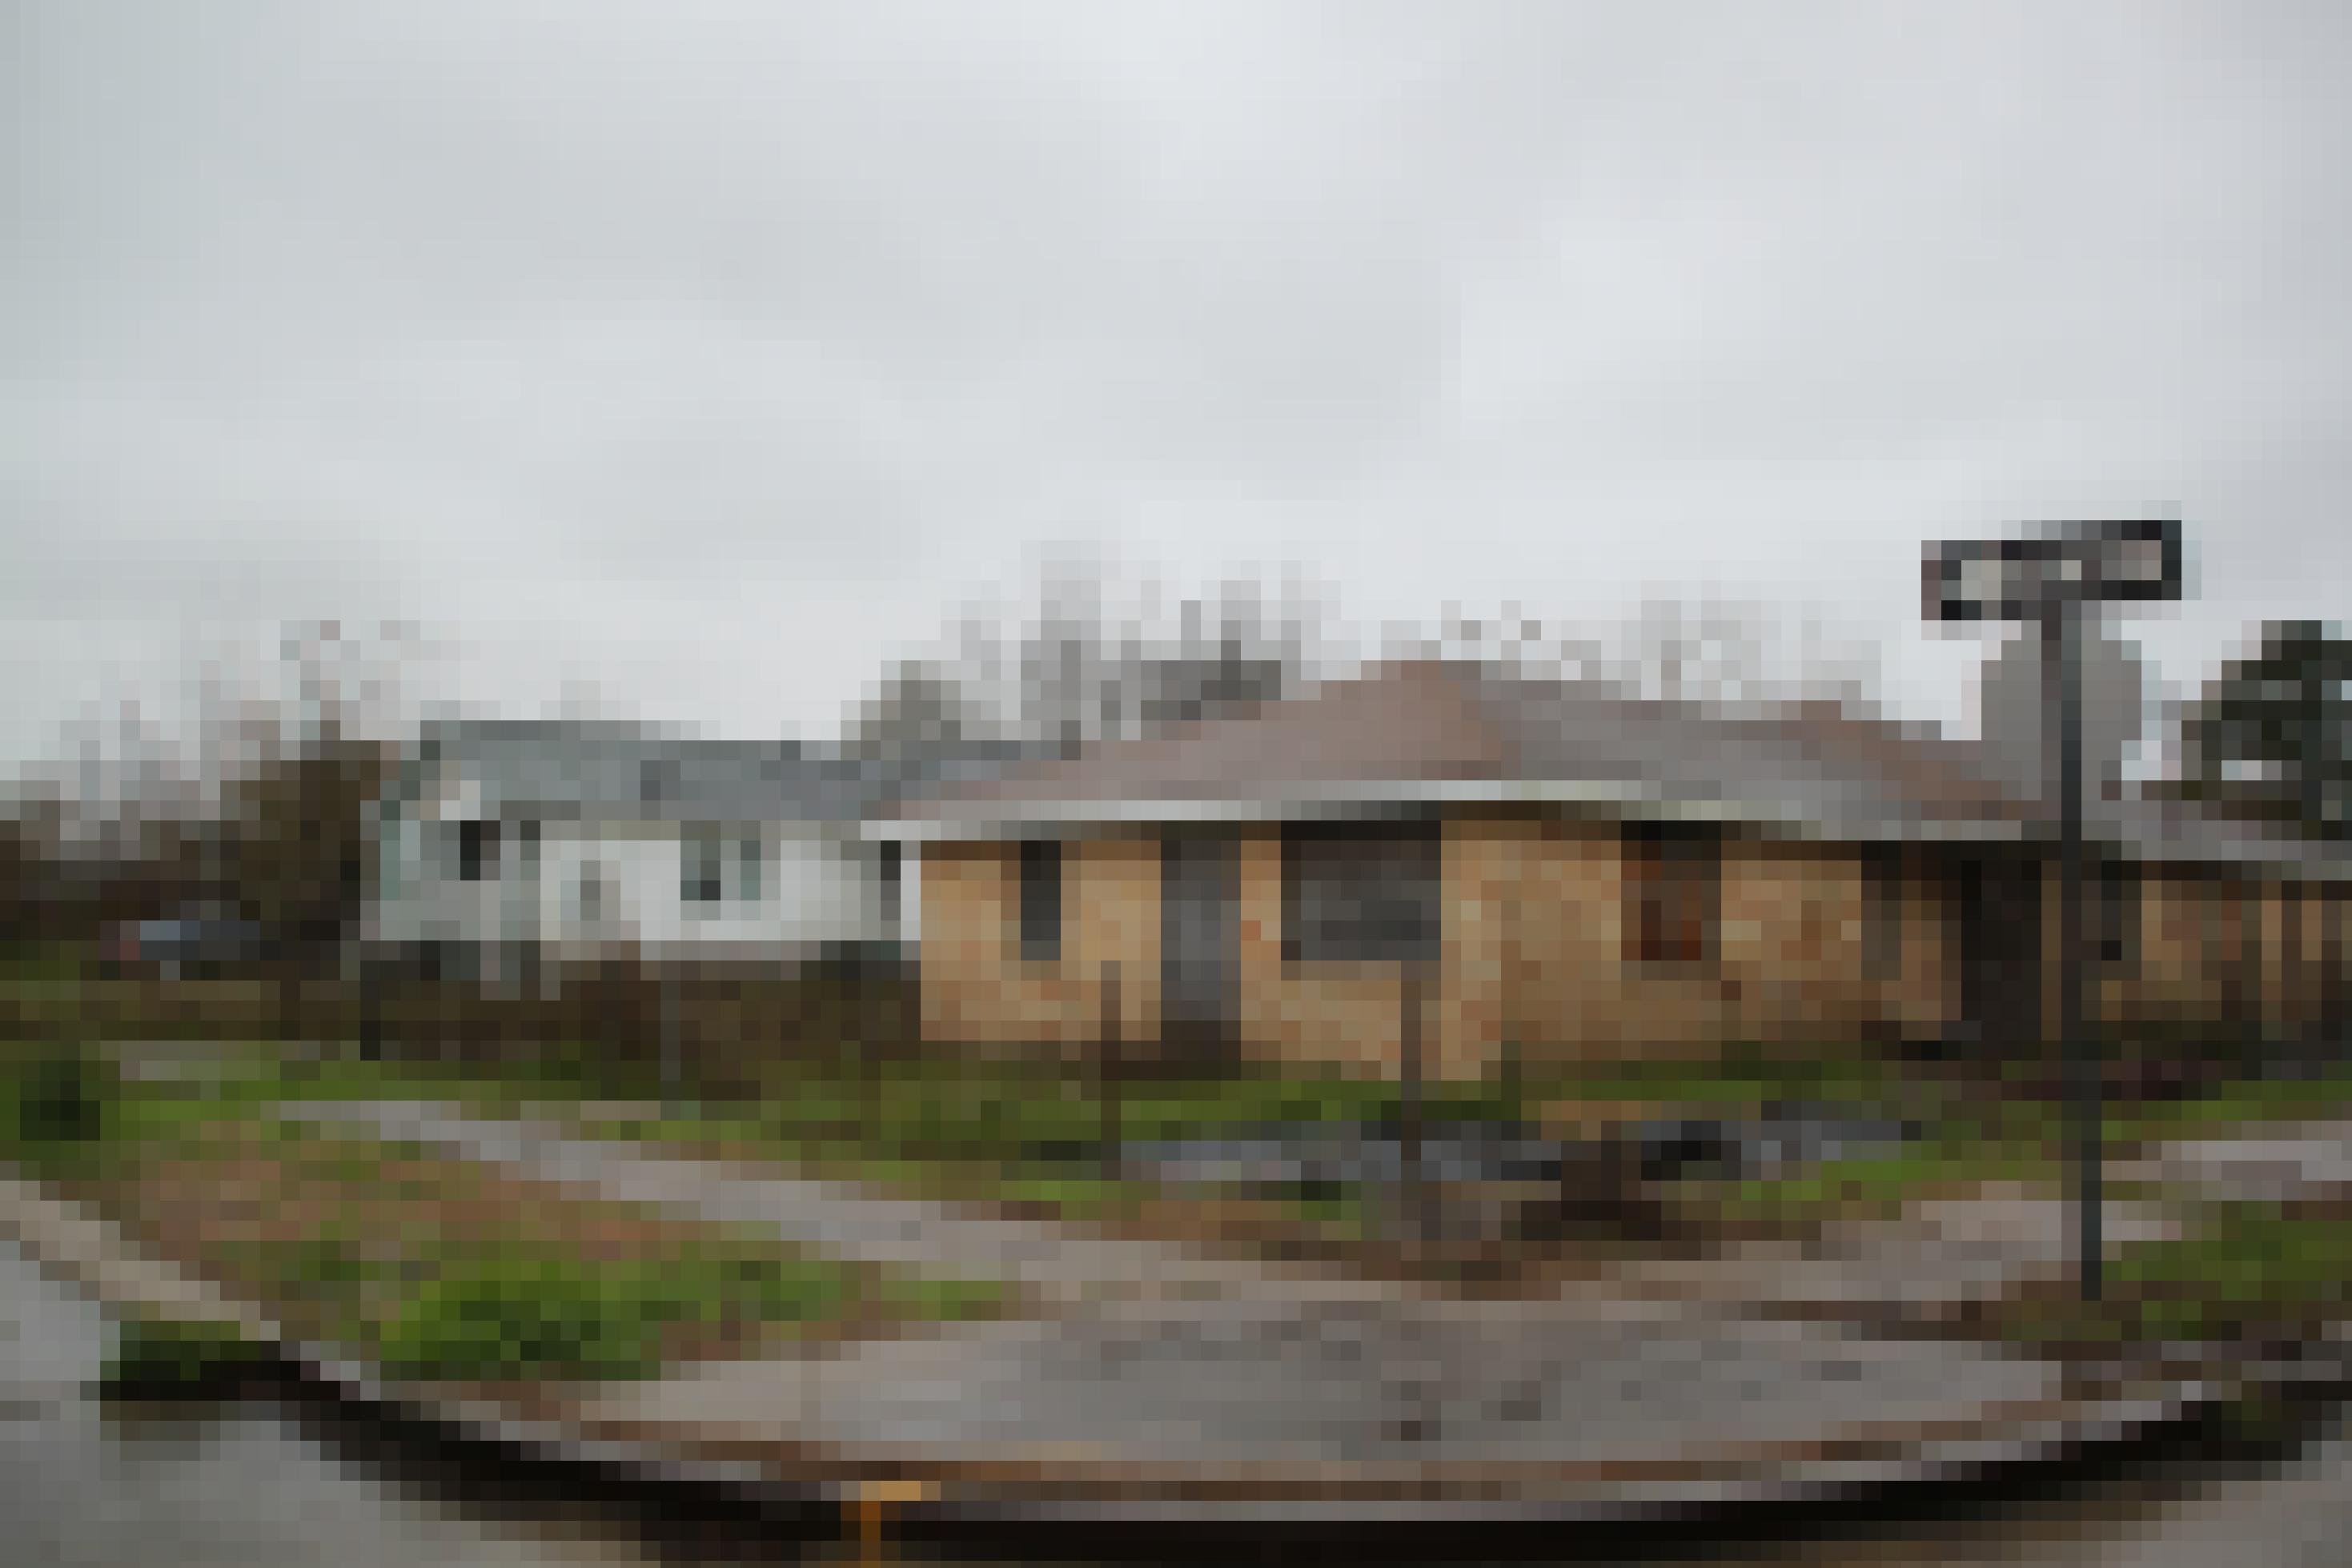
1919, 519, 2181, 620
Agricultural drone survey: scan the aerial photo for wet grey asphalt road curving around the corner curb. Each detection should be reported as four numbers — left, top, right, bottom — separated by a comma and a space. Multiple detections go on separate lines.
0, 1249, 2352, 1568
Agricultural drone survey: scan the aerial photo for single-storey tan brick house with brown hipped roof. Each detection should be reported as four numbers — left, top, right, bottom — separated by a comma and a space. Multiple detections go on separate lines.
875, 660, 2345, 1077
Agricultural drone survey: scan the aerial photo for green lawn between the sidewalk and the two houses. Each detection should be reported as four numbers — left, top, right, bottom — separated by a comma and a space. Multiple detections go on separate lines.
32, 1001, 2352, 1260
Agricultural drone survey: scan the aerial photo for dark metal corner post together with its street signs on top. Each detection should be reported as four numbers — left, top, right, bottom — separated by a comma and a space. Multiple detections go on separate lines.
1921, 519, 2182, 1300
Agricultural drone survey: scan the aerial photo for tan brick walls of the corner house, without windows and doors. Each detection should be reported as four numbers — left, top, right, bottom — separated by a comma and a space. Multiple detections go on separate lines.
922, 813, 2324, 1077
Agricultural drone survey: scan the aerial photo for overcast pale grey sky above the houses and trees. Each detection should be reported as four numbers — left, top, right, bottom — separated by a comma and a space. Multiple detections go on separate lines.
0, 0, 2352, 780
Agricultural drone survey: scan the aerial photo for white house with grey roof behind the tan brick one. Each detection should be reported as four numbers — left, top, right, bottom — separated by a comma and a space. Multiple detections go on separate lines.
364, 720, 973, 976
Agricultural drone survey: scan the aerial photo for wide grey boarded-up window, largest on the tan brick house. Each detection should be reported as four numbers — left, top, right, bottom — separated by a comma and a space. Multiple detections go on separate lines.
1282, 823, 1444, 964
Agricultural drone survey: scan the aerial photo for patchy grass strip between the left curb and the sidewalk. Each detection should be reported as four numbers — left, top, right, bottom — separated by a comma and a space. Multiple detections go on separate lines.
0, 1041, 1013, 1387
